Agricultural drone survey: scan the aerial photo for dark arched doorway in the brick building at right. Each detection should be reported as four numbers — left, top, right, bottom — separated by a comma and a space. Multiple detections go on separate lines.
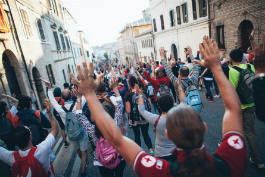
239, 20, 254, 49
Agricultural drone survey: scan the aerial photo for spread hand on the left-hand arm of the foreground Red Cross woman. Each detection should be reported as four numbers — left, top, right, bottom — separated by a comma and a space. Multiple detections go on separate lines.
70, 62, 102, 97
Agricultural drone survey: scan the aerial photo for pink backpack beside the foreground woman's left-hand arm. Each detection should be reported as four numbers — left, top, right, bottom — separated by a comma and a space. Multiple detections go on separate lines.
96, 137, 122, 169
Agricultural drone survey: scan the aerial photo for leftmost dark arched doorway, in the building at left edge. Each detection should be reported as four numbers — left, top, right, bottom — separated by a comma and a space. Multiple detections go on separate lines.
2, 52, 21, 96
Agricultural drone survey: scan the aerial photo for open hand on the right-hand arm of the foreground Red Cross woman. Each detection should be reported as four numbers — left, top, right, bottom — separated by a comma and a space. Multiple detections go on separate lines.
193, 40, 221, 70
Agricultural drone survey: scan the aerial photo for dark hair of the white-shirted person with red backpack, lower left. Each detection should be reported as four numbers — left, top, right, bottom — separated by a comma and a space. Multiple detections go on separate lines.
13, 125, 31, 149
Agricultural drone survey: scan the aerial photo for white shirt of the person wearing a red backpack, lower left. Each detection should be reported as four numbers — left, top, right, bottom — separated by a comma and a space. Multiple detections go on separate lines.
0, 134, 55, 177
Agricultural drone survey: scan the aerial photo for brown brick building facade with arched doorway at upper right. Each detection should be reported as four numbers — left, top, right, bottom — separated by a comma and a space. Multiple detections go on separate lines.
209, 0, 265, 55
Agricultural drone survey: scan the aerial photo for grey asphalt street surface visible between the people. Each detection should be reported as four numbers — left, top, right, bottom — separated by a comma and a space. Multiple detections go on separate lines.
54, 89, 265, 177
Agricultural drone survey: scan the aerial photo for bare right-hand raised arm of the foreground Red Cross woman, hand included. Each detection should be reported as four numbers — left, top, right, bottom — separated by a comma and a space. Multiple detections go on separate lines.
193, 40, 243, 135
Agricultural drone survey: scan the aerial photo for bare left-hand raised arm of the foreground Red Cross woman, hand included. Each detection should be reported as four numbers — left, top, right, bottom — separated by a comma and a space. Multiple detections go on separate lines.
71, 63, 142, 167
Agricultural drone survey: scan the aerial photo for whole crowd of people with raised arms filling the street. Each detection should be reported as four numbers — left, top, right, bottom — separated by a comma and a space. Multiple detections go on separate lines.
0, 29, 265, 177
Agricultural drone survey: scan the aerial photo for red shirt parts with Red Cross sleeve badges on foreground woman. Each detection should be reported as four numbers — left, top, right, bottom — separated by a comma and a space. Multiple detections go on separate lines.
133, 132, 247, 177
